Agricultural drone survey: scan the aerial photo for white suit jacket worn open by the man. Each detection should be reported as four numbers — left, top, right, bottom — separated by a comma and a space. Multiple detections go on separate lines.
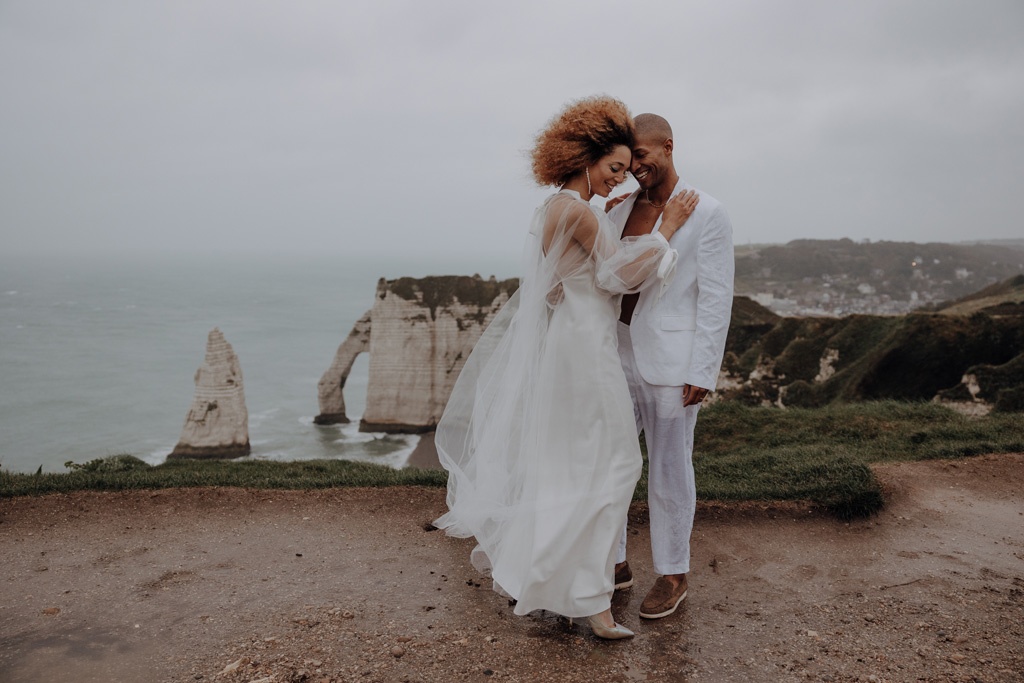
608, 179, 735, 390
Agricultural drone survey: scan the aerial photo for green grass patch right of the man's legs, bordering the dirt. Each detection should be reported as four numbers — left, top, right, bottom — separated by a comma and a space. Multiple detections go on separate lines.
637, 401, 1024, 519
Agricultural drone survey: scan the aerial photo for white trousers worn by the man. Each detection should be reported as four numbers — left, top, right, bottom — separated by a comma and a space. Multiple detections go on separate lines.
615, 323, 700, 574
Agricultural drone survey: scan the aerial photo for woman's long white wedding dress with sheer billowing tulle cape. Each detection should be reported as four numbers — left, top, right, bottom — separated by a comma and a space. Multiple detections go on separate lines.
434, 189, 677, 617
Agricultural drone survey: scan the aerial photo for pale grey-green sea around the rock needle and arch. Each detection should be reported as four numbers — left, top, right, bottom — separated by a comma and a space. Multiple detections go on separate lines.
0, 254, 516, 472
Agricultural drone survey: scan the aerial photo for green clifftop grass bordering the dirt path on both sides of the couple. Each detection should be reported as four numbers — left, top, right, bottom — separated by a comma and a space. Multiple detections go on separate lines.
0, 401, 1024, 518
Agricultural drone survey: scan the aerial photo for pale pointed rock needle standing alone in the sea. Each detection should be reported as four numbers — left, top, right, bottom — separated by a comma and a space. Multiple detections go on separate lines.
168, 328, 250, 458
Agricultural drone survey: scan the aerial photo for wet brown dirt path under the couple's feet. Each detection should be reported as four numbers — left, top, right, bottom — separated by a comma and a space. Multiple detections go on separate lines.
0, 455, 1024, 683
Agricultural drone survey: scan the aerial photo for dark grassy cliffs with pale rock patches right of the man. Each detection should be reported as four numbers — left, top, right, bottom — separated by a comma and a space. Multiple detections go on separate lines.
718, 305, 1024, 414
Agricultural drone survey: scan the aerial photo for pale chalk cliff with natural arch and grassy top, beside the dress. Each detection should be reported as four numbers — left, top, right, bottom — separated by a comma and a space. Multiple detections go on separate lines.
315, 275, 518, 433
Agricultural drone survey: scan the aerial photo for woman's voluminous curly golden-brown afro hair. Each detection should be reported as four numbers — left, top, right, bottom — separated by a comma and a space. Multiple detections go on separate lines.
530, 95, 635, 185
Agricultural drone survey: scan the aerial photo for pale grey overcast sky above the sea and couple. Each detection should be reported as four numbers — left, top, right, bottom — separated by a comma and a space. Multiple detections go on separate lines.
0, 0, 1024, 266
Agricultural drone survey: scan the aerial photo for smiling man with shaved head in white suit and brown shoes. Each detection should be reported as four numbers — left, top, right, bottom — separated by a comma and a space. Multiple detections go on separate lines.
608, 114, 734, 618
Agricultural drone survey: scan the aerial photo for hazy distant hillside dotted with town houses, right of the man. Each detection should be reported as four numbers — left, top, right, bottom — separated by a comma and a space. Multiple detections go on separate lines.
736, 240, 1024, 316
